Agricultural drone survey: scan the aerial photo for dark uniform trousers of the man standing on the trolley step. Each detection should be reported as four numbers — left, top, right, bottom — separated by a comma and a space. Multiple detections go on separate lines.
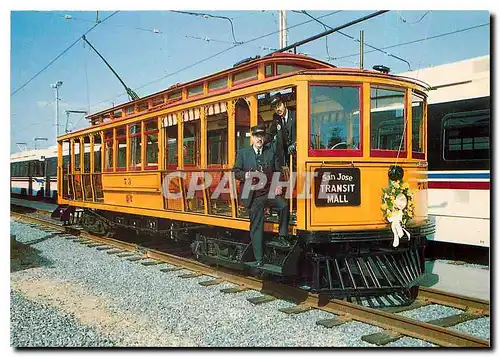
249, 193, 290, 261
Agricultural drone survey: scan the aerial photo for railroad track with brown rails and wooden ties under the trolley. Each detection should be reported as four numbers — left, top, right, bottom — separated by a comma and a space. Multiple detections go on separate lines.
11, 212, 490, 347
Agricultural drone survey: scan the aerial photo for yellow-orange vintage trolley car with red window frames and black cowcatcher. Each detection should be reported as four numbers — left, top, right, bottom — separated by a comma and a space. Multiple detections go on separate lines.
58, 53, 433, 301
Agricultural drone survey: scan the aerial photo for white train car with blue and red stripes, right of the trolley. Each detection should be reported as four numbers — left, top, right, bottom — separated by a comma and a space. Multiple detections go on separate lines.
401, 56, 491, 247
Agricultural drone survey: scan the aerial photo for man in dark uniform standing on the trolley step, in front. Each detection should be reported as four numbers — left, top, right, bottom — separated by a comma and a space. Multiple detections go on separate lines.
233, 125, 290, 267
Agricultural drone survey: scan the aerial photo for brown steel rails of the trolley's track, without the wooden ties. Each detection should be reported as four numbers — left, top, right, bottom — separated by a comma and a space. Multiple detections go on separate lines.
11, 212, 490, 347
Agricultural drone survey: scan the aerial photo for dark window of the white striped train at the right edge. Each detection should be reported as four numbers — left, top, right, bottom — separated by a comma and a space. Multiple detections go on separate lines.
443, 110, 490, 161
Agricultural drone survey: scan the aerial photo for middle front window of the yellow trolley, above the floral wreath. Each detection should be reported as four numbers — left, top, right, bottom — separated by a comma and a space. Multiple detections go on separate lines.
370, 86, 407, 157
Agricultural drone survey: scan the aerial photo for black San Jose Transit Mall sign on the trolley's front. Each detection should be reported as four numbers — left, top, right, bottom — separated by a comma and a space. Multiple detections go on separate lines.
314, 167, 361, 206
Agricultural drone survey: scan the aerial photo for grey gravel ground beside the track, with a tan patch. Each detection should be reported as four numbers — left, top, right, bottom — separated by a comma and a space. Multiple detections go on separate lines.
11, 220, 489, 347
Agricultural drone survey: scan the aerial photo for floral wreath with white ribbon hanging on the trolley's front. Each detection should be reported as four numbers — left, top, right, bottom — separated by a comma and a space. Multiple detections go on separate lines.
380, 166, 415, 247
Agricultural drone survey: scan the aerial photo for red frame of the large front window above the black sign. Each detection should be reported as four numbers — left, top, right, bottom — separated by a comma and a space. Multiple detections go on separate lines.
307, 82, 364, 157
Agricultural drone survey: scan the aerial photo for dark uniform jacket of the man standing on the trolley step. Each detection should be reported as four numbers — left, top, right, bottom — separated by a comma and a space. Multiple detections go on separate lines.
233, 144, 281, 208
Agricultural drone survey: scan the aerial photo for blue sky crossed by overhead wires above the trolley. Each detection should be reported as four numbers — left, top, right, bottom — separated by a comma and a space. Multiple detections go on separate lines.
10, 10, 490, 152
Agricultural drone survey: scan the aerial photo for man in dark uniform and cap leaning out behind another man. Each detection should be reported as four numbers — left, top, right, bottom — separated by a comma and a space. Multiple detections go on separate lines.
266, 92, 297, 166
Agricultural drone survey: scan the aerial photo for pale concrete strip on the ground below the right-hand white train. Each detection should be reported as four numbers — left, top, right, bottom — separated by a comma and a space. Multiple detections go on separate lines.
421, 260, 490, 301
